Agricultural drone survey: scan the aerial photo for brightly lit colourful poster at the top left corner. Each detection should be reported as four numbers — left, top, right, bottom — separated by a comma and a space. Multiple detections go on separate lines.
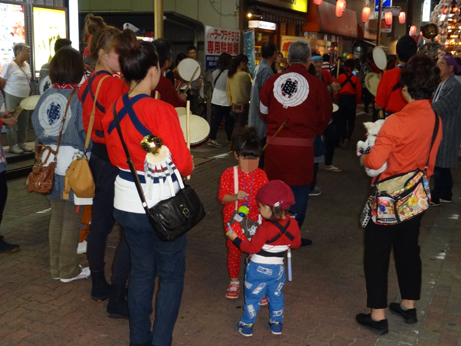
0, 3, 26, 72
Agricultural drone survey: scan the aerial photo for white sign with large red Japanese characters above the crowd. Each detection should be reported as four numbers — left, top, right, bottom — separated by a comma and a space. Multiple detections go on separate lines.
205, 26, 240, 70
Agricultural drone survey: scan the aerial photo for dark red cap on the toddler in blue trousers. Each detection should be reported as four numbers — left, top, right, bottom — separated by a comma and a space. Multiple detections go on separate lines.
256, 180, 295, 209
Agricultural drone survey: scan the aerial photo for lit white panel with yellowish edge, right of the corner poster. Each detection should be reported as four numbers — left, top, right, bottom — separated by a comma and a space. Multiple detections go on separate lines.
33, 6, 67, 71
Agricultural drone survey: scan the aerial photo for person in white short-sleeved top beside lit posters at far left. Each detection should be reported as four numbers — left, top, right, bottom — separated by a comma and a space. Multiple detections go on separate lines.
0, 43, 33, 154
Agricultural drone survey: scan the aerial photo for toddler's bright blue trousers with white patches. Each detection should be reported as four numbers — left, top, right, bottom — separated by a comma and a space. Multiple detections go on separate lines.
241, 262, 286, 324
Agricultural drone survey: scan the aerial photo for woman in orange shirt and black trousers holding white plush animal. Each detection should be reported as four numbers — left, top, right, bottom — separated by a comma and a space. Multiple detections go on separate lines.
356, 55, 442, 335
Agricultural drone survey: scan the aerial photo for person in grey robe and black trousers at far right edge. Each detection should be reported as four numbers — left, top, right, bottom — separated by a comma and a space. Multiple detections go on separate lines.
432, 55, 461, 205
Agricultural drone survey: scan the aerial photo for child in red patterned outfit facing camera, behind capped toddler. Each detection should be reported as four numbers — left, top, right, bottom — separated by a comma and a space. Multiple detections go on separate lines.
218, 127, 268, 299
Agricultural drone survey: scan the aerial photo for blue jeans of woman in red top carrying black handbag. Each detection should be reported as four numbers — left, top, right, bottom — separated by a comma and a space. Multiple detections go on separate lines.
114, 209, 187, 346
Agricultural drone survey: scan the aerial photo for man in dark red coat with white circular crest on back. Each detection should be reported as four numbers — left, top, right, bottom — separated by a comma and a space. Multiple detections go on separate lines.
259, 40, 333, 241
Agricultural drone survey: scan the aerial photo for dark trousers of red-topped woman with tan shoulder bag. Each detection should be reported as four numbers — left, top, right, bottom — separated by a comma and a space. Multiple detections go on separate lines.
87, 153, 131, 286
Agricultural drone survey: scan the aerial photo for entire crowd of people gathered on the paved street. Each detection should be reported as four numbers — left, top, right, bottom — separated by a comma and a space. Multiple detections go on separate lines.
0, 15, 461, 346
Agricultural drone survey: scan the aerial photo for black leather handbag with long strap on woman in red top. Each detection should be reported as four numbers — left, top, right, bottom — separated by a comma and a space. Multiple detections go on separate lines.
113, 103, 205, 241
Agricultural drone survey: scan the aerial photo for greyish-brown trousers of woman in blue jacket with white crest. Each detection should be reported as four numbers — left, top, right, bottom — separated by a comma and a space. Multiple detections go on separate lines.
48, 197, 83, 279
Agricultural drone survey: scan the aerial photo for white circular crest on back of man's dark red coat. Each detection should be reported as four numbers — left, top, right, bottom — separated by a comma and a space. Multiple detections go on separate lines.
274, 72, 309, 108
